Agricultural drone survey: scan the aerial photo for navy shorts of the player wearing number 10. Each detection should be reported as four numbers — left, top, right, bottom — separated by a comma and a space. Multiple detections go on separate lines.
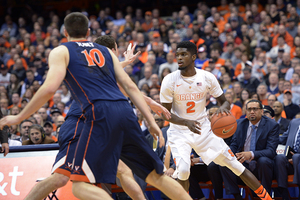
70, 101, 163, 183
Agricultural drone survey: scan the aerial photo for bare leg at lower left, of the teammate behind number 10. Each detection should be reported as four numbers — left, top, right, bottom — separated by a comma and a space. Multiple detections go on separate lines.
25, 173, 69, 200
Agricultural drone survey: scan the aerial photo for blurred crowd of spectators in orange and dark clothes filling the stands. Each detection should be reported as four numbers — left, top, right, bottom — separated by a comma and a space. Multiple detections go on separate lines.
0, 0, 300, 147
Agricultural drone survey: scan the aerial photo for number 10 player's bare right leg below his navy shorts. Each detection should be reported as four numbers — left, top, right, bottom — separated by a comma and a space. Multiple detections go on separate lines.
145, 170, 192, 200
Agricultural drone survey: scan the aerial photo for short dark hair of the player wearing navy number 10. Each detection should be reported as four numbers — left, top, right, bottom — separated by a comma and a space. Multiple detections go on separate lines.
64, 12, 89, 38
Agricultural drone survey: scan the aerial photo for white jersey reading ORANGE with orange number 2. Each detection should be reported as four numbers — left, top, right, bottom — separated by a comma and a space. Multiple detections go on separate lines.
160, 69, 223, 130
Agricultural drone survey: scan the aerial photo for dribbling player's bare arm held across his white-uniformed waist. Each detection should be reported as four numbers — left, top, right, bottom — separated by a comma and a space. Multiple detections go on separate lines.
162, 103, 201, 134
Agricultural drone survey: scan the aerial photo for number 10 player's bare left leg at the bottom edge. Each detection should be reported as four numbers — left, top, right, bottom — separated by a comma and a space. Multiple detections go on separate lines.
72, 181, 112, 200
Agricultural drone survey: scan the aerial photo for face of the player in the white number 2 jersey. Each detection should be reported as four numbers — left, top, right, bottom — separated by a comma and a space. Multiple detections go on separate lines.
176, 48, 196, 70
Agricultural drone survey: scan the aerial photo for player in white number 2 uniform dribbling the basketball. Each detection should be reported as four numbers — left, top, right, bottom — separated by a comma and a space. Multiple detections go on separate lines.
160, 41, 271, 199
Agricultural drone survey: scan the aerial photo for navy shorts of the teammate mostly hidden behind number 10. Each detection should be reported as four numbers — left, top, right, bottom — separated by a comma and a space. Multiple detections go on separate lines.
52, 116, 84, 177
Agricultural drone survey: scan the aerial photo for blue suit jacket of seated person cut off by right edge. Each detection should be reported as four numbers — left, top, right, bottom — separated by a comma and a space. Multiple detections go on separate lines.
279, 119, 300, 153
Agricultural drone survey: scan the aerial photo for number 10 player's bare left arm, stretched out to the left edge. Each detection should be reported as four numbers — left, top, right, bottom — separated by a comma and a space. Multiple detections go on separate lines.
0, 46, 69, 129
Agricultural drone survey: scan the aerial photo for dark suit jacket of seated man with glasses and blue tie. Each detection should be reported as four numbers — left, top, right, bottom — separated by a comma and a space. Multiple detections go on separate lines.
230, 116, 279, 160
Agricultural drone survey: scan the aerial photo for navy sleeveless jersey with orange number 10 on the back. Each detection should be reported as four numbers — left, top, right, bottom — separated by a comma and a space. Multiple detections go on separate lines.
62, 41, 126, 111
